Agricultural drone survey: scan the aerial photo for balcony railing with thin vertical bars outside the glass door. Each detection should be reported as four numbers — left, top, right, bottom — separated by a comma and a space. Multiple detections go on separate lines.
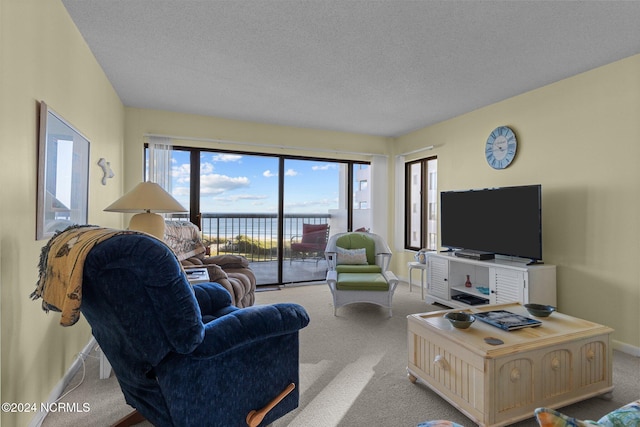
168, 213, 331, 262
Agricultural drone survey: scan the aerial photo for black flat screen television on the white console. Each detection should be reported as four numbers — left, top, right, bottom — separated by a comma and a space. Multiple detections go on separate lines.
440, 185, 542, 261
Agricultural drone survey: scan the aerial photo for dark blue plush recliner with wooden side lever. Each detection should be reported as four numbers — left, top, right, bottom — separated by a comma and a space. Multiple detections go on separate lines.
80, 234, 309, 427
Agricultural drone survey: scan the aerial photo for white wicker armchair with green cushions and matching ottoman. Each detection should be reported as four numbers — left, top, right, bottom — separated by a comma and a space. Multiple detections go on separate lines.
325, 232, 398, 316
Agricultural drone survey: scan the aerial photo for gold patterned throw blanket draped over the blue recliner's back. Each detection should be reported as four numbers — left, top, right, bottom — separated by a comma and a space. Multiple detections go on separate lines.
31, 225, 144, 326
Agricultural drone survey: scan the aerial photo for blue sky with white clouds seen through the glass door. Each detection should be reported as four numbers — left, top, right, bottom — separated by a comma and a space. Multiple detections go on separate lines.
171, 150, 340, 213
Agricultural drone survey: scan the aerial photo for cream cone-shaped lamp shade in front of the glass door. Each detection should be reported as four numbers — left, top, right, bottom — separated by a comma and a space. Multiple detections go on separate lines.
104, 181, 187, 213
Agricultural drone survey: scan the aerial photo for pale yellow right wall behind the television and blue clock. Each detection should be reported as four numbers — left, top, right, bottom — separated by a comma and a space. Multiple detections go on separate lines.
395, 55, 640, 351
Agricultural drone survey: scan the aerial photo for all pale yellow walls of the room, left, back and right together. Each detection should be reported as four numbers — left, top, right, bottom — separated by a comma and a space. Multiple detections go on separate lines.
0, 0, 640, 426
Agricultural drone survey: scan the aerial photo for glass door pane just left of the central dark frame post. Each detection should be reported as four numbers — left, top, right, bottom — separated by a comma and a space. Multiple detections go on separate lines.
198, 151, 280, 285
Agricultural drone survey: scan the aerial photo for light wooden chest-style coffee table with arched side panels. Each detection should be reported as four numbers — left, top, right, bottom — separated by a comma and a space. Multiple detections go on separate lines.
407, 303, 613, 426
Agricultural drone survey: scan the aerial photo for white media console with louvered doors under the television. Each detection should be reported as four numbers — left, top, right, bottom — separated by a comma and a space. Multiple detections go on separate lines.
425, 252, 556, 308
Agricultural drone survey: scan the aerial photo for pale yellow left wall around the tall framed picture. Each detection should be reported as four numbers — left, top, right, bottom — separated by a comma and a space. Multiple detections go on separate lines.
0, 0, 124, 427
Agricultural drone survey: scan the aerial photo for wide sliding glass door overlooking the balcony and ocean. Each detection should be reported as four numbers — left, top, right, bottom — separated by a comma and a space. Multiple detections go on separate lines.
146, 146, 371, 285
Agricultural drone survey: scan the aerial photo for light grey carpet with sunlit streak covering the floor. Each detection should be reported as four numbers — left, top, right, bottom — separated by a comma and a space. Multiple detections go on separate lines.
42, 283, 640, 427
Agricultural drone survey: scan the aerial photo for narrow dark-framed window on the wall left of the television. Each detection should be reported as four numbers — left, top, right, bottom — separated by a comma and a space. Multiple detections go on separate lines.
404, 157, 438, 250
